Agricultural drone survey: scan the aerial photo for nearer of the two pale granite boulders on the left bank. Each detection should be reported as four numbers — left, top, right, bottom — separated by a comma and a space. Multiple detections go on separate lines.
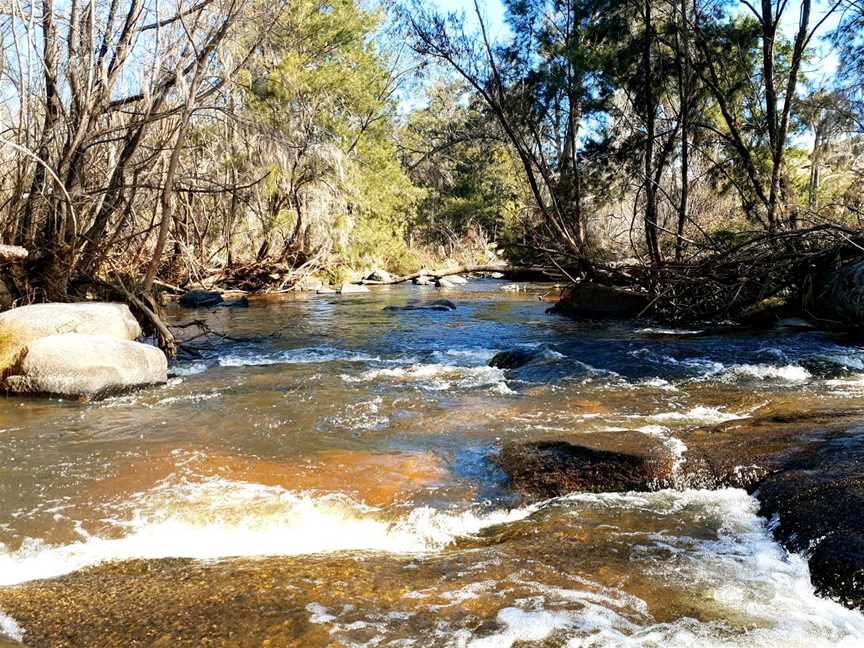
3, 333, 168, 398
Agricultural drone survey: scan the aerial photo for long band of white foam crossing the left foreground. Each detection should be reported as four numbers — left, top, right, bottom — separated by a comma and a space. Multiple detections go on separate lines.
0, 479, 535, 586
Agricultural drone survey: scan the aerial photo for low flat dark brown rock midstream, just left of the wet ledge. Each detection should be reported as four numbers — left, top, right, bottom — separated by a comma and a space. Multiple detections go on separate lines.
494, 441, 669, 498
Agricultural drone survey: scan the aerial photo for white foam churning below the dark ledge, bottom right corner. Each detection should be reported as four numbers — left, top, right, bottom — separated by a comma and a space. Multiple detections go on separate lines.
532, 489, 864, 648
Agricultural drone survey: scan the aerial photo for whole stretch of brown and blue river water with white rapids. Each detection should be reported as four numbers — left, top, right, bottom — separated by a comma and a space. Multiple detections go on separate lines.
0, 280, 864, 647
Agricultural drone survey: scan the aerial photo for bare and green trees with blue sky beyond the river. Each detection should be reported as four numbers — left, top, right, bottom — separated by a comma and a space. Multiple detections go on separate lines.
0, 0, 864, 322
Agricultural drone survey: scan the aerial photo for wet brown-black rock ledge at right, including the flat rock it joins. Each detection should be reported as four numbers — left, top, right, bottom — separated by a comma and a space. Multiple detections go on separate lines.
493, 410, 864, 609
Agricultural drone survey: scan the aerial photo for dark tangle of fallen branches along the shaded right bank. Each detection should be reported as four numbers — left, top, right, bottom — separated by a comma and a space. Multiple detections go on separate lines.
557, 224, 864, 328
